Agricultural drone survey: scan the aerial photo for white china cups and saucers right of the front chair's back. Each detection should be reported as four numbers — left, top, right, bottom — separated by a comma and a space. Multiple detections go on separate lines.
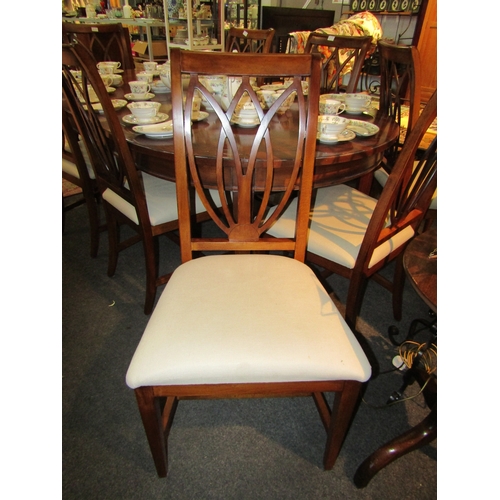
317, 93, 379, 144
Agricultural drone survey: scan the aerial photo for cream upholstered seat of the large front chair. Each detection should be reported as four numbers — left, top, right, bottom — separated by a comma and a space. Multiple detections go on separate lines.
127, 255, 370, 389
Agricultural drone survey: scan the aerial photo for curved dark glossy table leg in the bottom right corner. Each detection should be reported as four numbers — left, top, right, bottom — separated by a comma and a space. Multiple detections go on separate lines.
354, 406, 437, 488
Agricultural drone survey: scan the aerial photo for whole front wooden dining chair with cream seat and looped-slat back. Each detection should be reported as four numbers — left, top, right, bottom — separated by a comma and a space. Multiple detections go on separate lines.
126, 48, 371, 477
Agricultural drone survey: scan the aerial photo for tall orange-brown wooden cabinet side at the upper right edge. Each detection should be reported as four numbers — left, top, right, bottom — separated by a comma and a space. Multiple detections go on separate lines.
413, 0, 437, 102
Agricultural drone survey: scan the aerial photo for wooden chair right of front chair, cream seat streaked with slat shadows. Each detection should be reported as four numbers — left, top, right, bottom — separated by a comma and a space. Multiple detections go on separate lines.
269, 91, 437, 329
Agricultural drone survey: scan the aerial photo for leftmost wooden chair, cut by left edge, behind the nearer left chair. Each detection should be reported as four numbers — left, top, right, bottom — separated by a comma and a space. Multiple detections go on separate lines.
62, 110, 105, 257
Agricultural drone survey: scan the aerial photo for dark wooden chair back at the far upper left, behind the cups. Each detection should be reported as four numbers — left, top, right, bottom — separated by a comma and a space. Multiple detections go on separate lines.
62, 22, 135, 69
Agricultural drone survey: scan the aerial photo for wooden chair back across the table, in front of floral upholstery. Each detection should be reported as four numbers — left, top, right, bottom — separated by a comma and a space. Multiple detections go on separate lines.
304, 32, 372, 94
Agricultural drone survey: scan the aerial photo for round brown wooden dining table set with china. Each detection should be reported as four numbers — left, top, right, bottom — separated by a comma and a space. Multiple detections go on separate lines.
110, 70, 399, 190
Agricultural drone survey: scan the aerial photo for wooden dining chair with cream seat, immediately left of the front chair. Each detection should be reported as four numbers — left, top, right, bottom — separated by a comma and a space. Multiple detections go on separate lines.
62, 43, 213, 314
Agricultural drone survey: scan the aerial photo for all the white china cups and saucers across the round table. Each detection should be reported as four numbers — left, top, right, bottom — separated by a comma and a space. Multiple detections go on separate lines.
91, 61, 379, 144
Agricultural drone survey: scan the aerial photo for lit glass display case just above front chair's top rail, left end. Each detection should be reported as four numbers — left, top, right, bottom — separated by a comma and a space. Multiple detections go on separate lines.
165, 0, 224, 58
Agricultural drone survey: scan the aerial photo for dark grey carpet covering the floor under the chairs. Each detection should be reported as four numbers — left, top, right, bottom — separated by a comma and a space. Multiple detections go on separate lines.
62, 206, 437, 500
